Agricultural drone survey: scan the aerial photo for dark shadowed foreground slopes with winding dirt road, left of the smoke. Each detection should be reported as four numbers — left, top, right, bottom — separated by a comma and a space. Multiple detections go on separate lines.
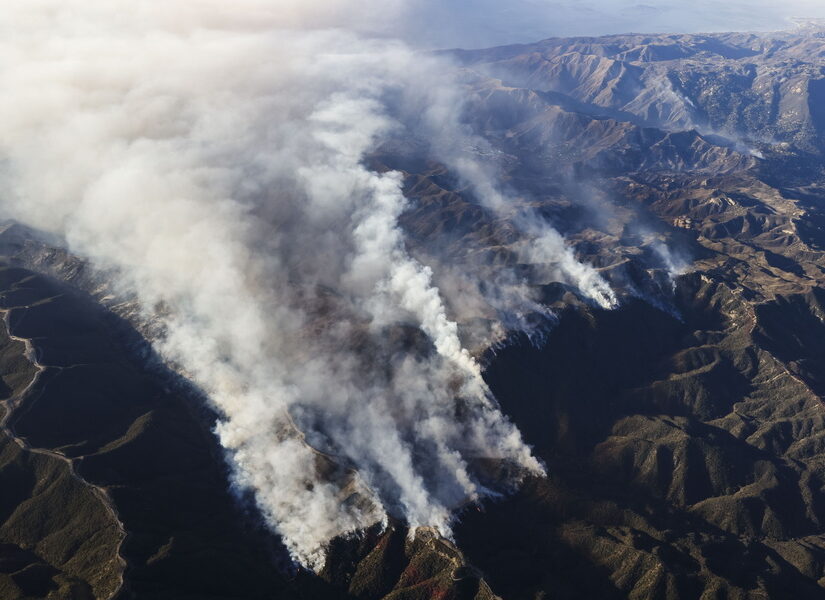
0, 254, 492, 600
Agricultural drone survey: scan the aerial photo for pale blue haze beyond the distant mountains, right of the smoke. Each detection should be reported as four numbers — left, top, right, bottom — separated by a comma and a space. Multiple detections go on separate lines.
395, 0, 825, 47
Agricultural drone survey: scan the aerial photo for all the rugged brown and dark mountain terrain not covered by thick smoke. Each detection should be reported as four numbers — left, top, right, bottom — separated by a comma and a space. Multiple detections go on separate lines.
0, 30, 825, 600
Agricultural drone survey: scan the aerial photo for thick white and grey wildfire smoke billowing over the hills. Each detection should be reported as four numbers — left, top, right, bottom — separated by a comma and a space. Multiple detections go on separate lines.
0, 0, 615, 567
